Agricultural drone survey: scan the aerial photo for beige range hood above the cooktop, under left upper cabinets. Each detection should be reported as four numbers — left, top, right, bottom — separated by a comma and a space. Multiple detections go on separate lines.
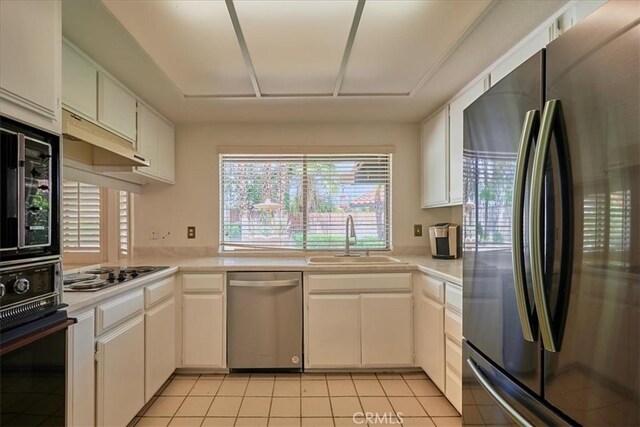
62, 110, 149, 172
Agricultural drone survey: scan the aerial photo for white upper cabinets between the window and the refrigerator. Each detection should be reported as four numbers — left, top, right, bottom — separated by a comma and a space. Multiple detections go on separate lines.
421, 76, 489, 208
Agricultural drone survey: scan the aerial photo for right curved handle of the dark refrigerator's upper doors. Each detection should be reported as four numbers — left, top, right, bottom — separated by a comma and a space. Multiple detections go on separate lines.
529, 99, 573, 352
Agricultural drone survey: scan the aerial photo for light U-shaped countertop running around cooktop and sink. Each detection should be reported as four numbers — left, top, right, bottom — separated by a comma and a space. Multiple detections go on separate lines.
63, 255, 462, 313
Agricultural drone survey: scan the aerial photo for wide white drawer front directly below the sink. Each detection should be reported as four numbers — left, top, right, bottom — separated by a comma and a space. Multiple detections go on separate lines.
308, 273, 411, 293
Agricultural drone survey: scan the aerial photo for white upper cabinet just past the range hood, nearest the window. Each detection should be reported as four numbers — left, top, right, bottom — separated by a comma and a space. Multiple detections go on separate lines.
136, 103, 175, 183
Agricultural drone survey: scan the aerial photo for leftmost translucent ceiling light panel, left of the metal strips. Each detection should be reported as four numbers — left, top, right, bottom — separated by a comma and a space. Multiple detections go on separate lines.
103, 0, 254, 96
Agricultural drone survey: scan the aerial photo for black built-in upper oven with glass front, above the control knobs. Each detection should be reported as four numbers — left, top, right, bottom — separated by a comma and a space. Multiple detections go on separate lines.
0, 117, 61, 265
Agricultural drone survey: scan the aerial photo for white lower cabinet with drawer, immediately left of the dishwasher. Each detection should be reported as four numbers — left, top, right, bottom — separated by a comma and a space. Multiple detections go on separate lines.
181, 274, 226, 368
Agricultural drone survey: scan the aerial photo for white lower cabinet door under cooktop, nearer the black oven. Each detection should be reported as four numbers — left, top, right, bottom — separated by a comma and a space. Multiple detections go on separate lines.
96, 316, 145, 426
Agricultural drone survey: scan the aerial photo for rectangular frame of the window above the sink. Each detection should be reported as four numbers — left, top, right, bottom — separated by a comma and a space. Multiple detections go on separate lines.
218, 152, 393, 253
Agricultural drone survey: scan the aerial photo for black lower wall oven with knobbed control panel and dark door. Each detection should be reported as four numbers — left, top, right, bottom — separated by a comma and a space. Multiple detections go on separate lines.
0, 260, 75, 427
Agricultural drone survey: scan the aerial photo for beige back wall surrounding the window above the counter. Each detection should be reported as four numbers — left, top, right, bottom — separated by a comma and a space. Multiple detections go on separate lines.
134, 123, 452, 251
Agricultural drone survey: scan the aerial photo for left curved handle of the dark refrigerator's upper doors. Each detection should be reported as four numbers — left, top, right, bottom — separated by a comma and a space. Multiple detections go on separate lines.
511, 110, 540, 342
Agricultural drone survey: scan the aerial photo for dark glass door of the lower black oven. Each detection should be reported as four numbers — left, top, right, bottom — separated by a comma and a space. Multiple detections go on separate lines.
0, 320, 67, 426
